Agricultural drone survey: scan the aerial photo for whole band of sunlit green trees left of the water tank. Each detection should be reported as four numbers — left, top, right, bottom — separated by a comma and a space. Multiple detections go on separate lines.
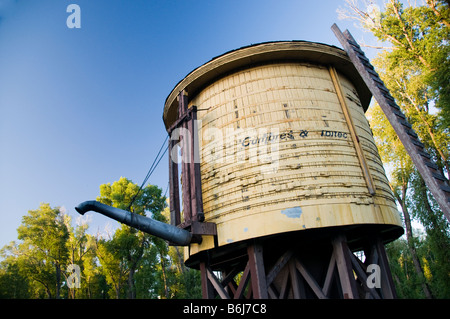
0, 177, 201, 299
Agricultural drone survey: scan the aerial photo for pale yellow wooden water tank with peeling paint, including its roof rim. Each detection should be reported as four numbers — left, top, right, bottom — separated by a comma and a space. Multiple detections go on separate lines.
163, 41, 402, 263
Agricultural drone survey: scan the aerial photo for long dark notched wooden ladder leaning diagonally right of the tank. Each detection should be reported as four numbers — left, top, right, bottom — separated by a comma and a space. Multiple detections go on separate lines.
331, 24, 450, 222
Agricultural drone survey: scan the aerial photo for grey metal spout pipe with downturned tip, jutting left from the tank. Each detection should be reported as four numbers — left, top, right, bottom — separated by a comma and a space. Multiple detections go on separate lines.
75, 200, 192, 246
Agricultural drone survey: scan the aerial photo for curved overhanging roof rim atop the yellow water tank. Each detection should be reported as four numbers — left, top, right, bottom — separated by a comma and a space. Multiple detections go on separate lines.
163, 40, 372, 128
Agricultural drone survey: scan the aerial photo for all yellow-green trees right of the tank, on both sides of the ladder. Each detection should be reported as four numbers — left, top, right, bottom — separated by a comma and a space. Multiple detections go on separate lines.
340, 0, 450, 298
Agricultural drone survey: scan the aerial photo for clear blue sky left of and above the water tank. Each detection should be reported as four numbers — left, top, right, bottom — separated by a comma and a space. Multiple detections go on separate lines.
0, 0, 382, 247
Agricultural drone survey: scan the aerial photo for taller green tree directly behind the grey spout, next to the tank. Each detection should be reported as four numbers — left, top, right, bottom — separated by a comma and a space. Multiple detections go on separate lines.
93, 177, 201, 299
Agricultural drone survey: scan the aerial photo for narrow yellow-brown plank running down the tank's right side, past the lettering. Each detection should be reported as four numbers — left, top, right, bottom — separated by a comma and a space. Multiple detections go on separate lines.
328, 66, 375, 195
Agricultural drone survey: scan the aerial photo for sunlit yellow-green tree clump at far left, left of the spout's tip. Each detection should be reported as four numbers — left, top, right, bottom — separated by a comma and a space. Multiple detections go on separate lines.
0, 204, 107, 298
